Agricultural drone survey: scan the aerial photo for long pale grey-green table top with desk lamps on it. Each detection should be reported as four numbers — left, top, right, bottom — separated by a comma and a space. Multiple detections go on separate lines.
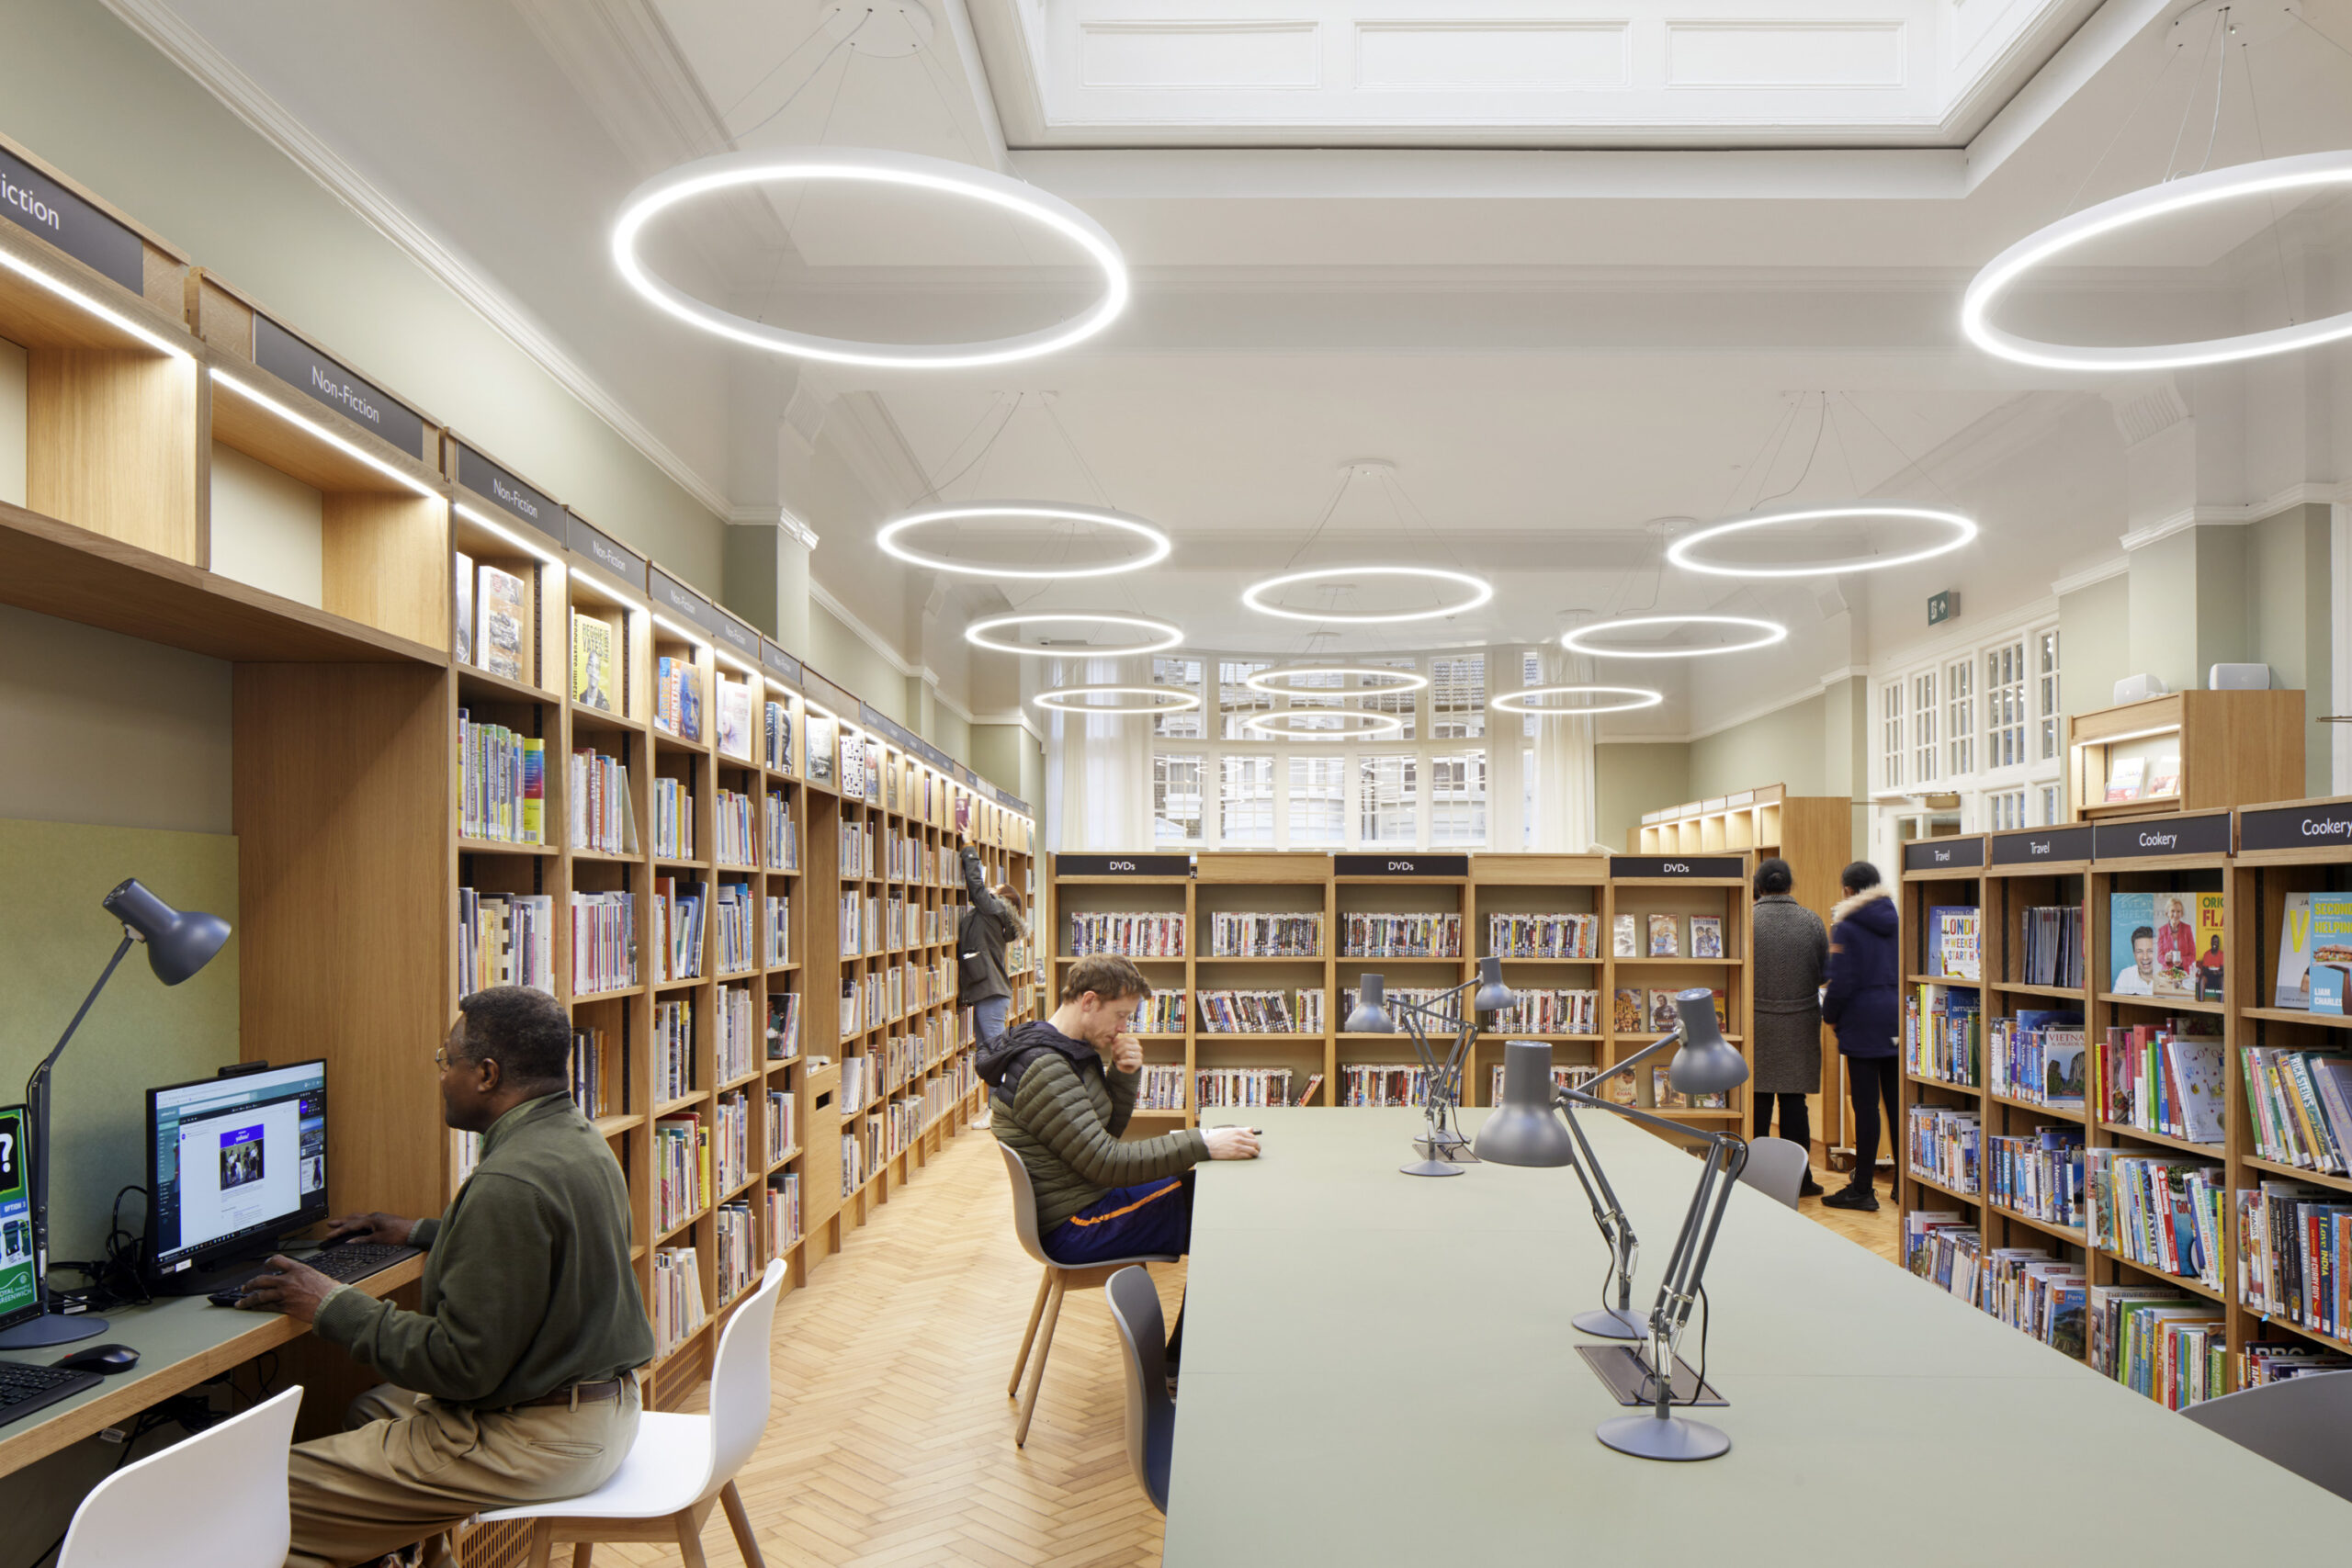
1162, 1110, 2352, 1568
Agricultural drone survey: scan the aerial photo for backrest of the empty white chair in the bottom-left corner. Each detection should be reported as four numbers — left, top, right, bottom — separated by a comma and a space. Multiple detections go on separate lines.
56, 1384, 301, 1568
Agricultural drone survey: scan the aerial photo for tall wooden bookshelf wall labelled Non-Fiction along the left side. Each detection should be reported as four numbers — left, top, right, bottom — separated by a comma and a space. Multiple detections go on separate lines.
0, 135, 1033, 1429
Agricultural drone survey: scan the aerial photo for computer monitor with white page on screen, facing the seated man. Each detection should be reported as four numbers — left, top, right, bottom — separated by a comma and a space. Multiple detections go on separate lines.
148, 1060, 327, 1295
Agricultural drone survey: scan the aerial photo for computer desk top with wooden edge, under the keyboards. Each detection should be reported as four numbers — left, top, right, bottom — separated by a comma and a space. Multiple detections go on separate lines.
0, 1256, 425, 1476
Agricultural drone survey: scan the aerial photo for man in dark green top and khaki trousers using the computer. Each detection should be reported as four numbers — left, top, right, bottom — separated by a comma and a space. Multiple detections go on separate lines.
244, 985, 654, 1568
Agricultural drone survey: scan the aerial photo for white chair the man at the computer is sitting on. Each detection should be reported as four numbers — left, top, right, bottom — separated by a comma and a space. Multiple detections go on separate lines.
475, 1258, 783, 1568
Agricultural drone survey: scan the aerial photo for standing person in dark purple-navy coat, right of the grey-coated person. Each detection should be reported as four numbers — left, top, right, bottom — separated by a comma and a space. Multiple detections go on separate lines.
1820, 861, 1903, 1211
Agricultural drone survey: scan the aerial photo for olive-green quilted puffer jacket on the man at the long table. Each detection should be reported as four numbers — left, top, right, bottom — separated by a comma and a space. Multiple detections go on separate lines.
976, 1021, 1209, 1236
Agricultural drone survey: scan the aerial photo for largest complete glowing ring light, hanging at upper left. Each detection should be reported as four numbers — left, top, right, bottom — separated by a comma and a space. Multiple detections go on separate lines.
612, 146, 1129, 369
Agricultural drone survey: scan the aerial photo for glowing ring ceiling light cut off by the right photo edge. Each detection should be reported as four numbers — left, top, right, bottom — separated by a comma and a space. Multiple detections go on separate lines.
1959, 150, 2352, 371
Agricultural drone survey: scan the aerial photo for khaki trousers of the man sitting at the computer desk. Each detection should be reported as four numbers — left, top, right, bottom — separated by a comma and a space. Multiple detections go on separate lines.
287, 1380, 639, 1568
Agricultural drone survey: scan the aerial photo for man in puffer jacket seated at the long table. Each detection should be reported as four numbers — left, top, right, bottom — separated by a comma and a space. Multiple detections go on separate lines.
978, 957, 1259, 1375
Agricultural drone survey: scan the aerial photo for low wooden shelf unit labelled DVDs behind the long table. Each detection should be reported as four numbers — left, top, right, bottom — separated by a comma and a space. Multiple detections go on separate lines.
1049, 851, 1750, 1138
